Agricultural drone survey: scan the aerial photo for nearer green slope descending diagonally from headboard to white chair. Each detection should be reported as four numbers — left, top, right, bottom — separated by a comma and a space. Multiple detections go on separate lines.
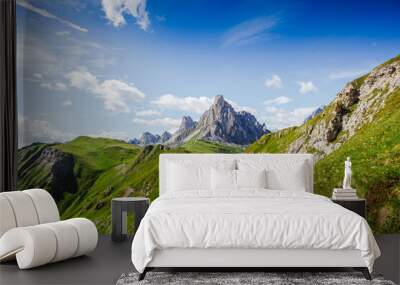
62, 140, 241, 233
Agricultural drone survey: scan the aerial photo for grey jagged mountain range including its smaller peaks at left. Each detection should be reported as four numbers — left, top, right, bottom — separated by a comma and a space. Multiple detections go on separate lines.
129, 95, 269, 146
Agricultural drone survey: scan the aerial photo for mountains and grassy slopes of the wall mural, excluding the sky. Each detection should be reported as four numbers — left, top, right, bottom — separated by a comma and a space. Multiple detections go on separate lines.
18, 56, 400, 233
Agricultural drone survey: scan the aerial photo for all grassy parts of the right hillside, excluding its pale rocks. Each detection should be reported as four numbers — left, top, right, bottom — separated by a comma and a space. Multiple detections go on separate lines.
245, 71, 400, 233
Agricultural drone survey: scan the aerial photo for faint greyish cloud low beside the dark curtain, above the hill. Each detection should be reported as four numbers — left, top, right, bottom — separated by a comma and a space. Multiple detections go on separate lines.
18, 115, 76, 146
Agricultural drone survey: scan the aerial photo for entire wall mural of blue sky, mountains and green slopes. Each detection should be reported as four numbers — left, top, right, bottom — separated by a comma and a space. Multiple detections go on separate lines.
17, 0, 400, 233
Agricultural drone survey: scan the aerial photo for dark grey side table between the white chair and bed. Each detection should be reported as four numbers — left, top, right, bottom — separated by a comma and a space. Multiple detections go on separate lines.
111, 197, 150, 241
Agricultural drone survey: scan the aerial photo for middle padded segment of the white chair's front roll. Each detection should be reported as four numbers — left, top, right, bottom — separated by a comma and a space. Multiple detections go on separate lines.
41, 221, 79, 262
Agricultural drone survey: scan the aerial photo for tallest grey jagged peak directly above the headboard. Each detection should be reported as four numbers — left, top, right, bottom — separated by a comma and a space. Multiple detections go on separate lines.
189, 95, 268, 145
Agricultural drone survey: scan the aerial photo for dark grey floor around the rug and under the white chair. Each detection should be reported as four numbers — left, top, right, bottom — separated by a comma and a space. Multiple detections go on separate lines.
0, 235, 400, 285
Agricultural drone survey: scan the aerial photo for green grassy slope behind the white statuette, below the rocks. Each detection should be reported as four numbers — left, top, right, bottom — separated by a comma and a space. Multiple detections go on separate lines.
315, 89, 400, 233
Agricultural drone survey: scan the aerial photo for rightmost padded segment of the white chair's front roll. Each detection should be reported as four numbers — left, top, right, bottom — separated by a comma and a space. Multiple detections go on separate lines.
63, 218, 98, 257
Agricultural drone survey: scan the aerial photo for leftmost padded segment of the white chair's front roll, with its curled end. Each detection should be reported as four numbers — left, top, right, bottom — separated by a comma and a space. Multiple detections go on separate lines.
0, 225, 57, 269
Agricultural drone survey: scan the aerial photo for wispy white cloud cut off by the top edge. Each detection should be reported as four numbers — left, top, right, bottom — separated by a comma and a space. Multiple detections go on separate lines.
101, 0, 150, 31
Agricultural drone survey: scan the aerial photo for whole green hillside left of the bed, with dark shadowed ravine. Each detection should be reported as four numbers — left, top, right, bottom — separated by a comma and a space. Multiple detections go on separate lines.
19, 137, 242, 233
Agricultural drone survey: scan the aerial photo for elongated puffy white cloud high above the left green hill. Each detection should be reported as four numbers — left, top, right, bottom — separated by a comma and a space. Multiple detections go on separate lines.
66, 68, 146, 113
